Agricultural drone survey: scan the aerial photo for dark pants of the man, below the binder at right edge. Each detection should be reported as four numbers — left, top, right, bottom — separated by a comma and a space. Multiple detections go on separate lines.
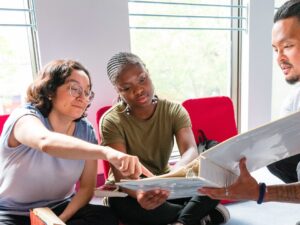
267, 154, 300, 183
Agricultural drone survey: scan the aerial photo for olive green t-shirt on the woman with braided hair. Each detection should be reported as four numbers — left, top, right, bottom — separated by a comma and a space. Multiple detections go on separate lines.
100, 100, 191, 180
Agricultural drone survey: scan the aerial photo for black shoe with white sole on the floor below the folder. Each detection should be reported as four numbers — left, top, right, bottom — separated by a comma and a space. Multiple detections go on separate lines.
200, 204, 230, 225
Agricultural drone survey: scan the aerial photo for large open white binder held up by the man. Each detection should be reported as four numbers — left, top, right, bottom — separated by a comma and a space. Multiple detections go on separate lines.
117, 112, 300, 198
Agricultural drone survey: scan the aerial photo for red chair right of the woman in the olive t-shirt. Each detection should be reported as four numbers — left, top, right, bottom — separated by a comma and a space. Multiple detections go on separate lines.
182, 96, 238, 204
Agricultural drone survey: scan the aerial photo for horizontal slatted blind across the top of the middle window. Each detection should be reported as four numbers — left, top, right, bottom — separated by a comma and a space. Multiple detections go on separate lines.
128, 0, 247, 31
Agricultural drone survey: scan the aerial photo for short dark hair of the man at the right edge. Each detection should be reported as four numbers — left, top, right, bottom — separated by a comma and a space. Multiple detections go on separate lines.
273, 0, 300, 23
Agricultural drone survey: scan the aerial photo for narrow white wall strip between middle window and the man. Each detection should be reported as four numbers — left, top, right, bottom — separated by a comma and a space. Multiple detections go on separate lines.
241, 0, 274, 132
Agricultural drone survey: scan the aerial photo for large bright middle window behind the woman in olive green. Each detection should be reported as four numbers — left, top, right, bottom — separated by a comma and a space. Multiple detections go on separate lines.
129, 0, 246, 103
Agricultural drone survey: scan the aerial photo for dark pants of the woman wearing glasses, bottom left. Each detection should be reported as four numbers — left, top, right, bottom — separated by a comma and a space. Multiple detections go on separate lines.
0, 203, 118, 225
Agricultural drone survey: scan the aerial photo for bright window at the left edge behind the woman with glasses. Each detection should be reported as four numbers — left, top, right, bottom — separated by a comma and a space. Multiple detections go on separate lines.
0, 0, 39, 114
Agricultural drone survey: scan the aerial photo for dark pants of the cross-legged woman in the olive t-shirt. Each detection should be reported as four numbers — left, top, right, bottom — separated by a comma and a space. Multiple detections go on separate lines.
108, 196, 219, 225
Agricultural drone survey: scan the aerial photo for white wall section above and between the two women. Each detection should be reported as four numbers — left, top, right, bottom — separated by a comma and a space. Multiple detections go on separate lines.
36, 0, 130, 124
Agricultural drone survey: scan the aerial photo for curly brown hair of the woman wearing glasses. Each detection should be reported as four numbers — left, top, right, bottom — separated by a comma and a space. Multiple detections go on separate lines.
26, 59, 92, 120
